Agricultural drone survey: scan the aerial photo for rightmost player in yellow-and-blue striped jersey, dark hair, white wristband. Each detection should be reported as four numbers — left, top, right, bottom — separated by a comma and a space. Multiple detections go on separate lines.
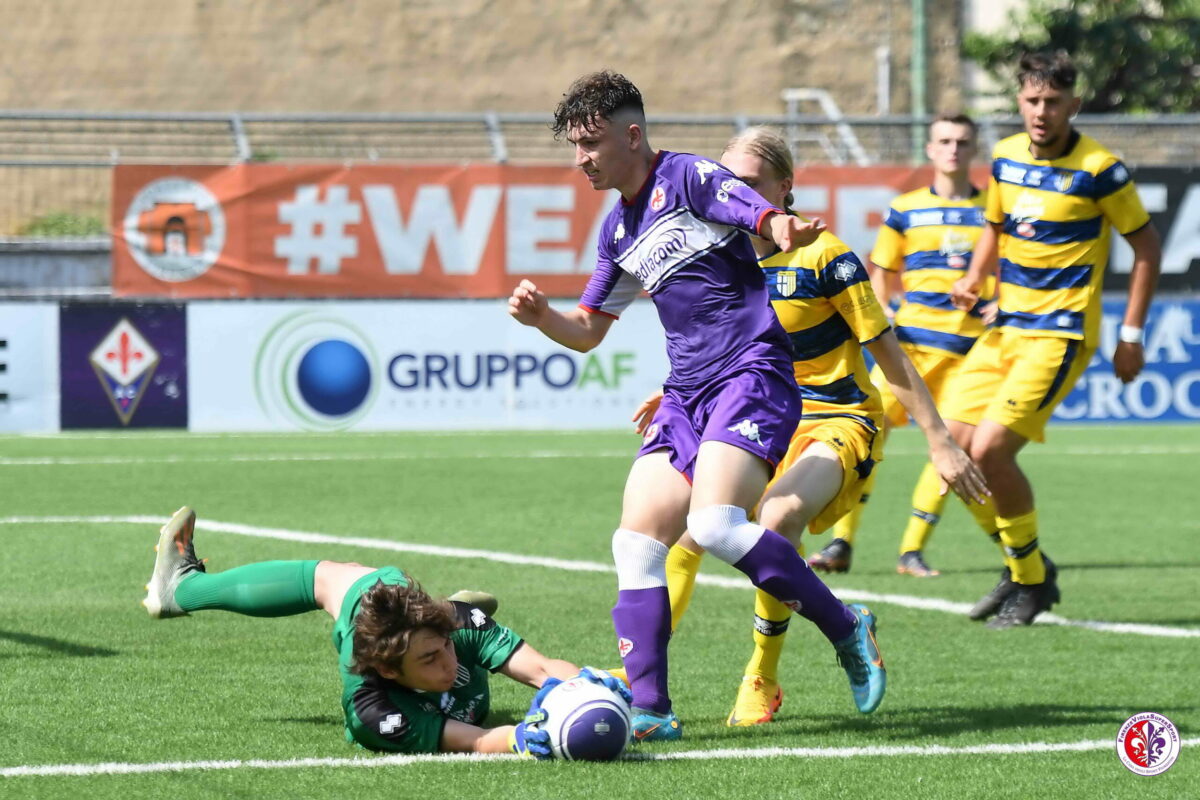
944, 54, 1162, 628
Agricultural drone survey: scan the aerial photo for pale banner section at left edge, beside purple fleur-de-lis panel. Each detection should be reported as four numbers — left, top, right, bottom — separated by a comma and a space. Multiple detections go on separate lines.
0, 302, 59, 433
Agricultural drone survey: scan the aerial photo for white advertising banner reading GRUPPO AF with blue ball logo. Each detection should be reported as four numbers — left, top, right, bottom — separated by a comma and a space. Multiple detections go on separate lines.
187, 300, 668, 431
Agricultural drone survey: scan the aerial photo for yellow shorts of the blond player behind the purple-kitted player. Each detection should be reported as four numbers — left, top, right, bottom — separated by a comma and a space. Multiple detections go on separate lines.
767, 416, 883, 534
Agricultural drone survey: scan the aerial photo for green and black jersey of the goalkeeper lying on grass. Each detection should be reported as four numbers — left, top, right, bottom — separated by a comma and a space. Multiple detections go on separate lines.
334, 567, 522, 753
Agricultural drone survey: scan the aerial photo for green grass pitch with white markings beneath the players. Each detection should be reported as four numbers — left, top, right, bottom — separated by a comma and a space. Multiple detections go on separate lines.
0, 426, 1200, 800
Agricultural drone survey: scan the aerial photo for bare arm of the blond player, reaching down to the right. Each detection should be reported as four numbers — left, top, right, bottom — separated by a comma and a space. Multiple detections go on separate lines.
866, 331, 991, 503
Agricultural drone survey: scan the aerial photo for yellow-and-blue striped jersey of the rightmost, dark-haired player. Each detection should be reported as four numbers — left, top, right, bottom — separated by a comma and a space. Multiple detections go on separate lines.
985, 131, 1150, 345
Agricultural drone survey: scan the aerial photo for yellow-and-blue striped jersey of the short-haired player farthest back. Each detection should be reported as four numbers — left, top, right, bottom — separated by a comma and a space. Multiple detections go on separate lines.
871, 187, 992, 356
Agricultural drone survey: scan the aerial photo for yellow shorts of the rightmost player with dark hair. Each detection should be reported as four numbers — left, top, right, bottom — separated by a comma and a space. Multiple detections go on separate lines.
942, 329, 1096, 441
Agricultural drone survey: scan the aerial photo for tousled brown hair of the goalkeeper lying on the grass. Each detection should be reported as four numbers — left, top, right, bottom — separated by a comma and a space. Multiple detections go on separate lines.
350, 578, 458, 675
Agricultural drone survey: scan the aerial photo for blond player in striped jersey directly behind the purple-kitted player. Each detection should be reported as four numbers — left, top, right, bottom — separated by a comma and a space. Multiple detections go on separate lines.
635, 128, 985, 726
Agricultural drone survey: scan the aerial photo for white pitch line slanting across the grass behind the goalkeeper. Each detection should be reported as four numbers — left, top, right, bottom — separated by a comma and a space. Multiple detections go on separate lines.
0, 516, 1200, 638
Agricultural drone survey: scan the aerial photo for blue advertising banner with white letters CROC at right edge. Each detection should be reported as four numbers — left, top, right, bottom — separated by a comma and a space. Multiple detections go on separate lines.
1054, 299, 1200, 422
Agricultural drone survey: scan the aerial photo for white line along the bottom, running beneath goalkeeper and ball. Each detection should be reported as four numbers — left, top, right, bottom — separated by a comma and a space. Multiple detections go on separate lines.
0, 739, 1200, 777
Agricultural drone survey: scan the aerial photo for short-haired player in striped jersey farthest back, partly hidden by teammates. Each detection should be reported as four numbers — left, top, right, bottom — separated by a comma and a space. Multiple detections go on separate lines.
809, 114, 996, 577
